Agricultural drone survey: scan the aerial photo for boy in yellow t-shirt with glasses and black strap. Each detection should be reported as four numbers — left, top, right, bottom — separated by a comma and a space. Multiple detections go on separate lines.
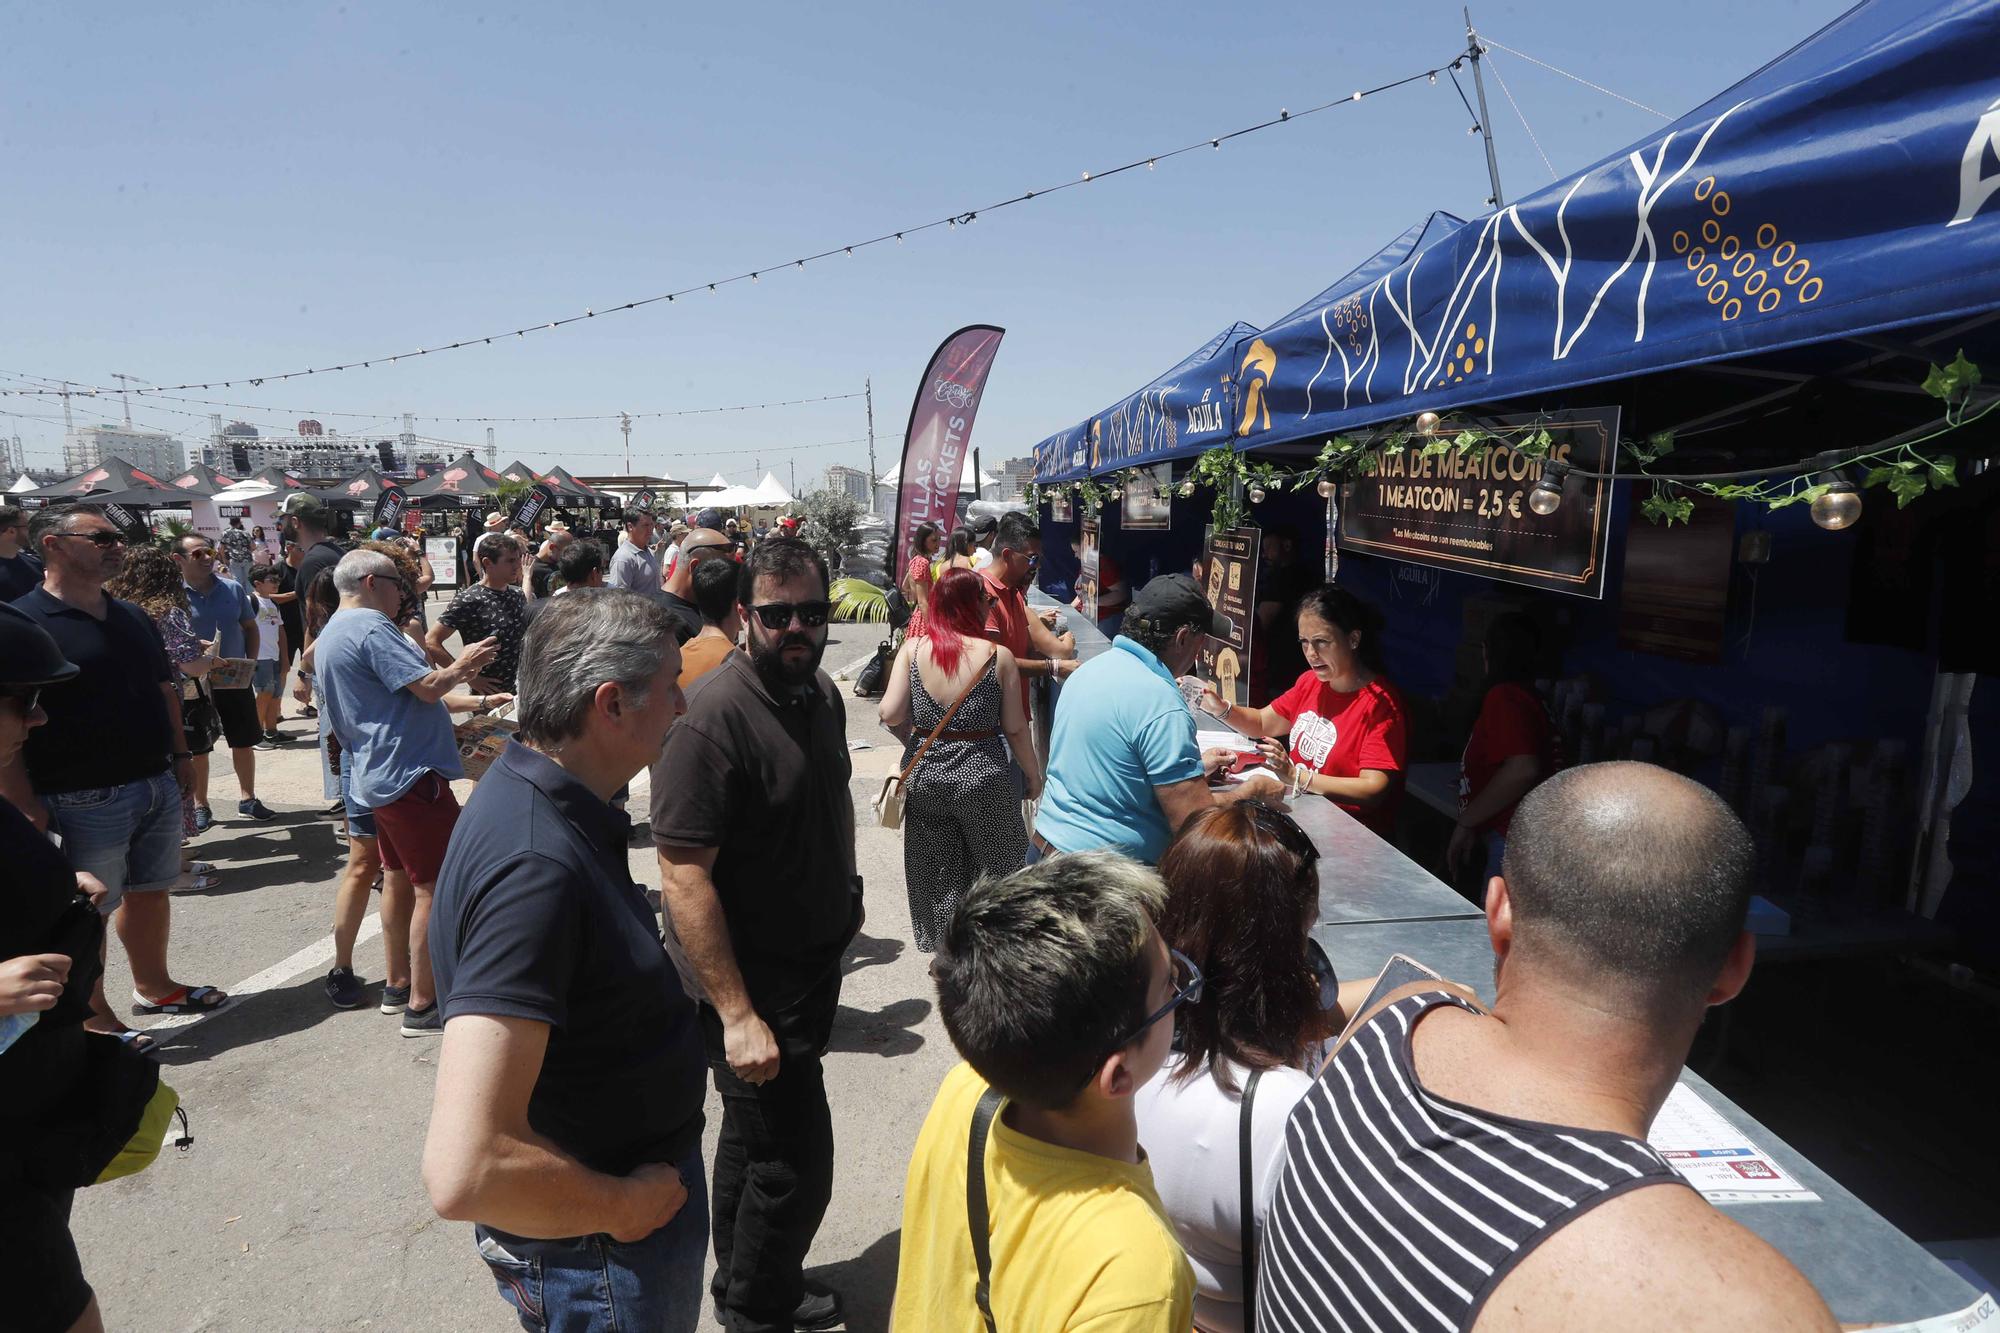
890, 853, 1202, 1333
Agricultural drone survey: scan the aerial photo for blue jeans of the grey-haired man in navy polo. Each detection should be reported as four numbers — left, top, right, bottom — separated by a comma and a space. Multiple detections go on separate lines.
472, 1149, 708, 1333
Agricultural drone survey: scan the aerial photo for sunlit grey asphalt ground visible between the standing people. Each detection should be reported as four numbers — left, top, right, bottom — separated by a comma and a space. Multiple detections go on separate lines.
60, 624, 936, 1331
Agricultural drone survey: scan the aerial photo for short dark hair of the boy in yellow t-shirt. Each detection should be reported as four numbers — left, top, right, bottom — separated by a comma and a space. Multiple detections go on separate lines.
932, 853, 1166, 1109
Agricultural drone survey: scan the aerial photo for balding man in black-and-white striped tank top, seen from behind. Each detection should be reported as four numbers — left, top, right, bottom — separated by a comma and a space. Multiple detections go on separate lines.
1258, 763, 1836, 1333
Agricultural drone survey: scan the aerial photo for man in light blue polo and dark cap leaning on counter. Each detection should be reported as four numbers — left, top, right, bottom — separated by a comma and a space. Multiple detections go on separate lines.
1034, 574, 1284, 865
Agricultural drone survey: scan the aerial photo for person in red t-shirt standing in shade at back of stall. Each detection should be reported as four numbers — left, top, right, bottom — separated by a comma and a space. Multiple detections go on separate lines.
1444, 610, 1562, 879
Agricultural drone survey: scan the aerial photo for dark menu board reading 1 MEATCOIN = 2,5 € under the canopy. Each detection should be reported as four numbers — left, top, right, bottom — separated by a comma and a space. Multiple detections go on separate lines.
1340, 406, 1618, 598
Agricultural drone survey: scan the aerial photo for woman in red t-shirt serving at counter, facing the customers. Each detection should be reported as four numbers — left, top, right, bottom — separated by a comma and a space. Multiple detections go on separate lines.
1202, 582, 1410, 837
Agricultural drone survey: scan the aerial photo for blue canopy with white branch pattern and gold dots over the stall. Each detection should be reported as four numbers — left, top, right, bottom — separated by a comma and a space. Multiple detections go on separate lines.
1036, 0, 2000, 480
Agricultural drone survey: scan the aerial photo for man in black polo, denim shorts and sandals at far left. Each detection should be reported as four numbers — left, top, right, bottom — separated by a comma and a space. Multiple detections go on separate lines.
0, 504, 228, 1033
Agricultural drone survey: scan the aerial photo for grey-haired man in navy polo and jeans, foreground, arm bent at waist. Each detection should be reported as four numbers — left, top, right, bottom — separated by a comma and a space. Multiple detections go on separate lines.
424, 588, 708, 1329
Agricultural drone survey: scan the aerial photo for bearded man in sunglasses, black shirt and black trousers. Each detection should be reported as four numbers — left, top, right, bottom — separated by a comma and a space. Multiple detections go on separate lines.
652, 534, 862, 1331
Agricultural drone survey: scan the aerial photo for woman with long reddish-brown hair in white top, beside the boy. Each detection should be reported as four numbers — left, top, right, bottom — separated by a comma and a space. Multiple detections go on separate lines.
1136, 801, 1374, 1333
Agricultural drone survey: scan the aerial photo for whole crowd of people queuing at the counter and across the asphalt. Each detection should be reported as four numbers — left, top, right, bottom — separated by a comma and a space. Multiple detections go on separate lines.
0, 496, 1832, 1333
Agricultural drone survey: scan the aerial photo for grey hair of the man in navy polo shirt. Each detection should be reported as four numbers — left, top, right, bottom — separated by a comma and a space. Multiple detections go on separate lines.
514, 586, 678, 747
